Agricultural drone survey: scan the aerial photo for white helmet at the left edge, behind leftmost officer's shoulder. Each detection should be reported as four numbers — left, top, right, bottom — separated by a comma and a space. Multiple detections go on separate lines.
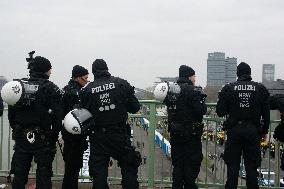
1, 81, 23, 106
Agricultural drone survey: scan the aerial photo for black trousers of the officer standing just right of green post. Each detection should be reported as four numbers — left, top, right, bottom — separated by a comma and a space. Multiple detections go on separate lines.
171, 135, 203, 189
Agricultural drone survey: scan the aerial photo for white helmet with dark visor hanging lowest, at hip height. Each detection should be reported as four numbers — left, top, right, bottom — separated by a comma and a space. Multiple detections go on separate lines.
63, 108, 94, 135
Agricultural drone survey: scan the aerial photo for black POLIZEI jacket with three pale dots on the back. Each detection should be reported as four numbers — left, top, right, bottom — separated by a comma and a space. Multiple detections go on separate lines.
80, 71, 140, 126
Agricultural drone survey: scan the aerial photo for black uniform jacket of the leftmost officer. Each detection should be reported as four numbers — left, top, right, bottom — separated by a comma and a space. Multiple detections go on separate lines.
8, 72, 64, 140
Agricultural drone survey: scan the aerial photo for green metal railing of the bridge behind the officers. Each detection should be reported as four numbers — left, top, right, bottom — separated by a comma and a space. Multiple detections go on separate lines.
0, 100, 284, 189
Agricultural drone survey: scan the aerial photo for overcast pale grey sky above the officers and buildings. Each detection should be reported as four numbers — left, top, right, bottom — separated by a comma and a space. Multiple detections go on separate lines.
0, 0, 284, 88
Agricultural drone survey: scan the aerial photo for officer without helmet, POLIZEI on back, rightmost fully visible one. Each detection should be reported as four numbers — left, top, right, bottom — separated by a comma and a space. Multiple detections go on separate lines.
216, 62, 270, 189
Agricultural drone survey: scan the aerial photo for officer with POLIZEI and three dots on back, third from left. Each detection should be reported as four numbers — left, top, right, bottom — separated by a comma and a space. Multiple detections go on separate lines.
80, 59, 141, 189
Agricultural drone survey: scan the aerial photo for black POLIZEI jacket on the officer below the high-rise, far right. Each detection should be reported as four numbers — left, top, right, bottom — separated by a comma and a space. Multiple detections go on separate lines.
216, 75, 270, 134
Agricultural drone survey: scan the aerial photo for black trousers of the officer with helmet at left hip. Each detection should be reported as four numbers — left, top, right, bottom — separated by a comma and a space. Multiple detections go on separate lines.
89, 132, 141, 189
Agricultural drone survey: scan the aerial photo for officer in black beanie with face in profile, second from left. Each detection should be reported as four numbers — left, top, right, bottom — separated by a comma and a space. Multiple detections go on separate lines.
61, 65, 89, 189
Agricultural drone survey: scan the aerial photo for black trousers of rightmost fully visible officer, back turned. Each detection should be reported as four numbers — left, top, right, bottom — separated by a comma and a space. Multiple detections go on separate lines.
224, 124, 261, 189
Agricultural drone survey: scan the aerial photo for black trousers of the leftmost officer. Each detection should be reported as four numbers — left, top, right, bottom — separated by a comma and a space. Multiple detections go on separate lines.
11, 142, 56, 189
